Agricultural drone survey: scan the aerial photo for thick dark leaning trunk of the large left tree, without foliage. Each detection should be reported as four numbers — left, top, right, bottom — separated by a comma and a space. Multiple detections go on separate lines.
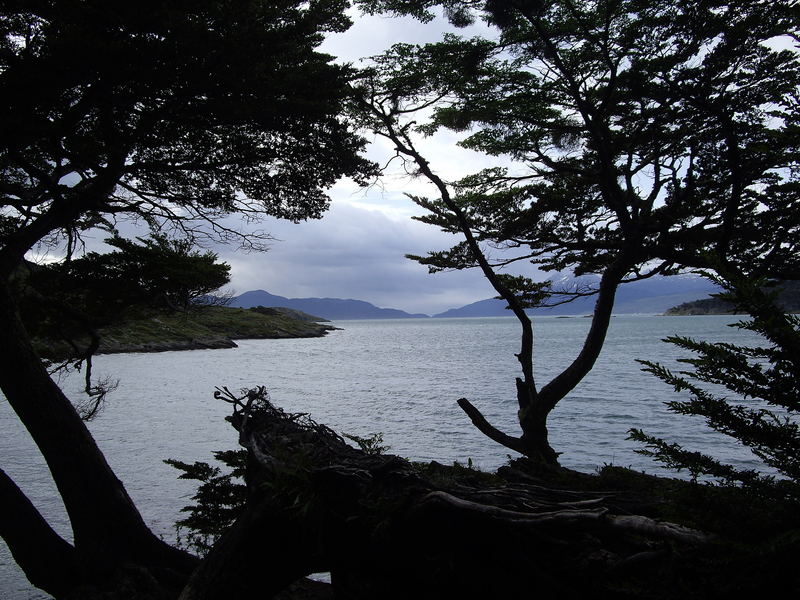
0, 281, 196, 596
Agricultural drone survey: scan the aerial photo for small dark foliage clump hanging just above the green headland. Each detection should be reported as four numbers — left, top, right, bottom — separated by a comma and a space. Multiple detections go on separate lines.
15, 234, 230, 376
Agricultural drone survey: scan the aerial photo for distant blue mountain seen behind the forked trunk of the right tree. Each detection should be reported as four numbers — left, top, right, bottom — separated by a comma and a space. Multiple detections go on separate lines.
434, 275, 719, 318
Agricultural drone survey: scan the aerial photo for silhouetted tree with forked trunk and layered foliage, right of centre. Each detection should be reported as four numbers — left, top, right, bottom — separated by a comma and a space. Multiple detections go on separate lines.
359, 0, 800, 464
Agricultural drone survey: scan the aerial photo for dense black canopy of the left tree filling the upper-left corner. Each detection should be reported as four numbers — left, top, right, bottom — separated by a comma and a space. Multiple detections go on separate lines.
0, 0, 370, 272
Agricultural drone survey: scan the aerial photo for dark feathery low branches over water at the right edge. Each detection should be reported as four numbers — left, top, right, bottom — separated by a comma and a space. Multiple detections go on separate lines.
630, 273, 800, 502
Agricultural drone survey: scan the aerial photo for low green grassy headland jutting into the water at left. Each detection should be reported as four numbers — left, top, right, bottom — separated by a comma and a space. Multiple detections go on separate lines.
34, 306, 337, 360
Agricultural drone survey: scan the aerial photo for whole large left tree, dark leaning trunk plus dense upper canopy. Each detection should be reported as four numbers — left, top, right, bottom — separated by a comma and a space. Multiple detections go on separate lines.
0, 0, 372, 598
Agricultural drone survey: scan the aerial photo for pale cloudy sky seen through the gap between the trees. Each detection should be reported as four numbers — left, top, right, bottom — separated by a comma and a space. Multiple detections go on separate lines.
205, 13, 506, 314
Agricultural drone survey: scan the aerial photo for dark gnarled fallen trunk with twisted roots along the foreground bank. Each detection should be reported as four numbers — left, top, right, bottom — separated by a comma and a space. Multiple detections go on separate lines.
172, 388, 797, 600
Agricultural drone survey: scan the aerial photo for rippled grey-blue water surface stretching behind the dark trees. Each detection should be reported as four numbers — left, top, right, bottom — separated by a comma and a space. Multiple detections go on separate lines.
0, 315, 772, 600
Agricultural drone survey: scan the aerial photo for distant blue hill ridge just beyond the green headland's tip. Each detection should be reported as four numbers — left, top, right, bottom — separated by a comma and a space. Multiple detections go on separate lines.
230, 290, 428, 321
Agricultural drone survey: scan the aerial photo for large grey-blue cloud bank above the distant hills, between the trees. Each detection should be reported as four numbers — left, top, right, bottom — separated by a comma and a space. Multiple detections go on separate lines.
216, 200, 500, 314
